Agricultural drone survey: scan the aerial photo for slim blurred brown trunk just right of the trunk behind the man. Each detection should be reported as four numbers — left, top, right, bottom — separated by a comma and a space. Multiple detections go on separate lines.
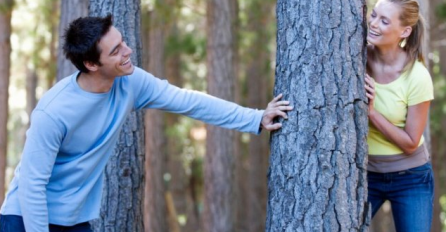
144, 0, 168, 232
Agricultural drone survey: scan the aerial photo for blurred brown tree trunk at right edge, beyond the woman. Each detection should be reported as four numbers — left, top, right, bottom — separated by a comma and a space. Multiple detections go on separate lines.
428, 0, 446, 232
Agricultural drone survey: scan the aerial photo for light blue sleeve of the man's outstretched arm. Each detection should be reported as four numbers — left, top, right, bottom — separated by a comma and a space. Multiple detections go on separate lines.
129, 69, 264, 134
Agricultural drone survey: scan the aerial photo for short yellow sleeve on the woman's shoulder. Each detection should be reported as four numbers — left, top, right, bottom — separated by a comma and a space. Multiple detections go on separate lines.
407, 63, 434, 106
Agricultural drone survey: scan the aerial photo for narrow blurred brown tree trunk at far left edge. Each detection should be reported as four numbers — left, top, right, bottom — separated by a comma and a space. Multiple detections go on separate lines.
0, 0, 14, 204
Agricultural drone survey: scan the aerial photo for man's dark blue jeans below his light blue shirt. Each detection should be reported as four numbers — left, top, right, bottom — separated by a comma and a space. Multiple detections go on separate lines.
0, 215, 92, 232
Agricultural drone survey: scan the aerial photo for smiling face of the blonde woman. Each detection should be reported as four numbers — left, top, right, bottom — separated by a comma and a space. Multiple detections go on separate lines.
367, 0, 410, 47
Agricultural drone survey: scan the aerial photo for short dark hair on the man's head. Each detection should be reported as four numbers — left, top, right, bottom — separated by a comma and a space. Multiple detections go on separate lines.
63, 14, 113, 73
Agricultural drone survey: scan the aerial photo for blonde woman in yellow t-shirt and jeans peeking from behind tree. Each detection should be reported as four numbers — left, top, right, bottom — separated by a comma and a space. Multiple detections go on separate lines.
365, 0, 434, 232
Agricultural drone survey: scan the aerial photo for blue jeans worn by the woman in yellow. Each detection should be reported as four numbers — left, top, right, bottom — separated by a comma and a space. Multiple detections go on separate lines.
367, 163, 434, 232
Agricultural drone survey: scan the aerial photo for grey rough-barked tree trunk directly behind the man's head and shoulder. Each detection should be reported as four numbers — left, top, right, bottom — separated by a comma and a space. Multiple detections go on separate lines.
89, 0, 144, 232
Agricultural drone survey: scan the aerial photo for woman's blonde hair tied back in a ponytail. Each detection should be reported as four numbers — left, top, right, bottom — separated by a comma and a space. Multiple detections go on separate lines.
387, 0, 425, 70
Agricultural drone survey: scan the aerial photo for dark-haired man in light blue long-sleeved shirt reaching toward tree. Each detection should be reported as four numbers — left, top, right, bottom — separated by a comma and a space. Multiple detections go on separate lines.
0, 16, 292, 232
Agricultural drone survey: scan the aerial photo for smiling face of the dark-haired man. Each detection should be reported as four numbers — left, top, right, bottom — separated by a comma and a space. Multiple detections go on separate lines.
98, 26, 134, 78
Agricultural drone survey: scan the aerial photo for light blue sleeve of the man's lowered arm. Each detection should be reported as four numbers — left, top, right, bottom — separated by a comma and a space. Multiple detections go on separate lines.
18, 110, 63, 232
